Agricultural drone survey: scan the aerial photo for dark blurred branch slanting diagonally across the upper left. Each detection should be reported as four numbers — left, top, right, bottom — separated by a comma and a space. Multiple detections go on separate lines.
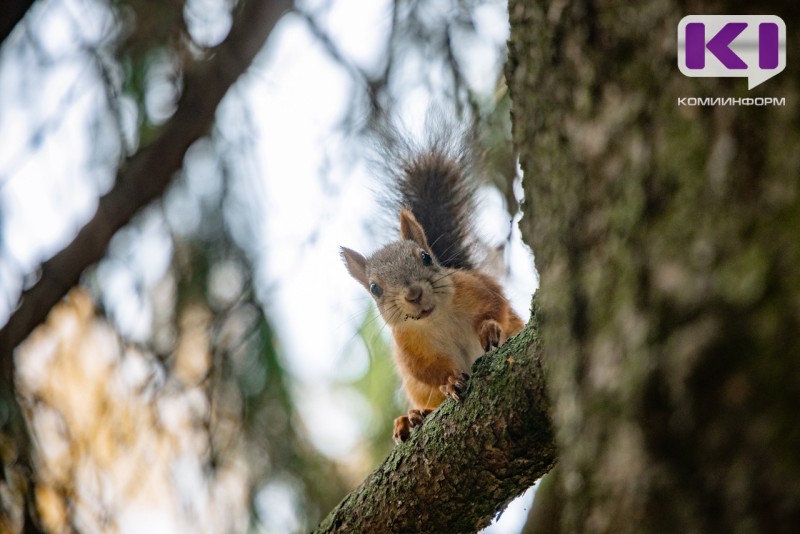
0, 0, 291, 366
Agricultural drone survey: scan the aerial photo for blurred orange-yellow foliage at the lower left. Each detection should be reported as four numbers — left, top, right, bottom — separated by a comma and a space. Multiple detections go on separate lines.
18, 289, 248, 532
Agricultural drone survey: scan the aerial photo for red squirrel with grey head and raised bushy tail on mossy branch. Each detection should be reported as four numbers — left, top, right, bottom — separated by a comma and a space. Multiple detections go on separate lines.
341, 129, 524, 443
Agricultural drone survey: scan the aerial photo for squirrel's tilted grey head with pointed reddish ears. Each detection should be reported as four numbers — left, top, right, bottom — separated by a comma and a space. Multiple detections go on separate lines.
342, 209, 453, 326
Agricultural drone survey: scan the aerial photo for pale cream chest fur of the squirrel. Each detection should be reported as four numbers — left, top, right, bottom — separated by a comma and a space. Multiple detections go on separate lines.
420, 312, 484, 373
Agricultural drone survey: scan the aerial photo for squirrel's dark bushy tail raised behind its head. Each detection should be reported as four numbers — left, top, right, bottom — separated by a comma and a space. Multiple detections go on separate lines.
380, 122, 476, 269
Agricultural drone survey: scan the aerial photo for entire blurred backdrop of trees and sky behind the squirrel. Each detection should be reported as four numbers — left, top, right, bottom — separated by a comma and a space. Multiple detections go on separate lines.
0, 0, 535, 532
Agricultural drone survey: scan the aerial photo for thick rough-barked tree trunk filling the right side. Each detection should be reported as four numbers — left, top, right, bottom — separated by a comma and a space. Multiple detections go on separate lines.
507, 0, 800, 533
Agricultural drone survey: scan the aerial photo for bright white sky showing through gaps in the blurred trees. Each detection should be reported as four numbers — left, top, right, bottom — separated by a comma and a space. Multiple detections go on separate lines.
0, 0, 536, 533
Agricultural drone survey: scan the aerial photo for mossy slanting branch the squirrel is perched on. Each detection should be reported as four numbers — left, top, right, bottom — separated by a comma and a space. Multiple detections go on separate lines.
315, 316, 556, 533
